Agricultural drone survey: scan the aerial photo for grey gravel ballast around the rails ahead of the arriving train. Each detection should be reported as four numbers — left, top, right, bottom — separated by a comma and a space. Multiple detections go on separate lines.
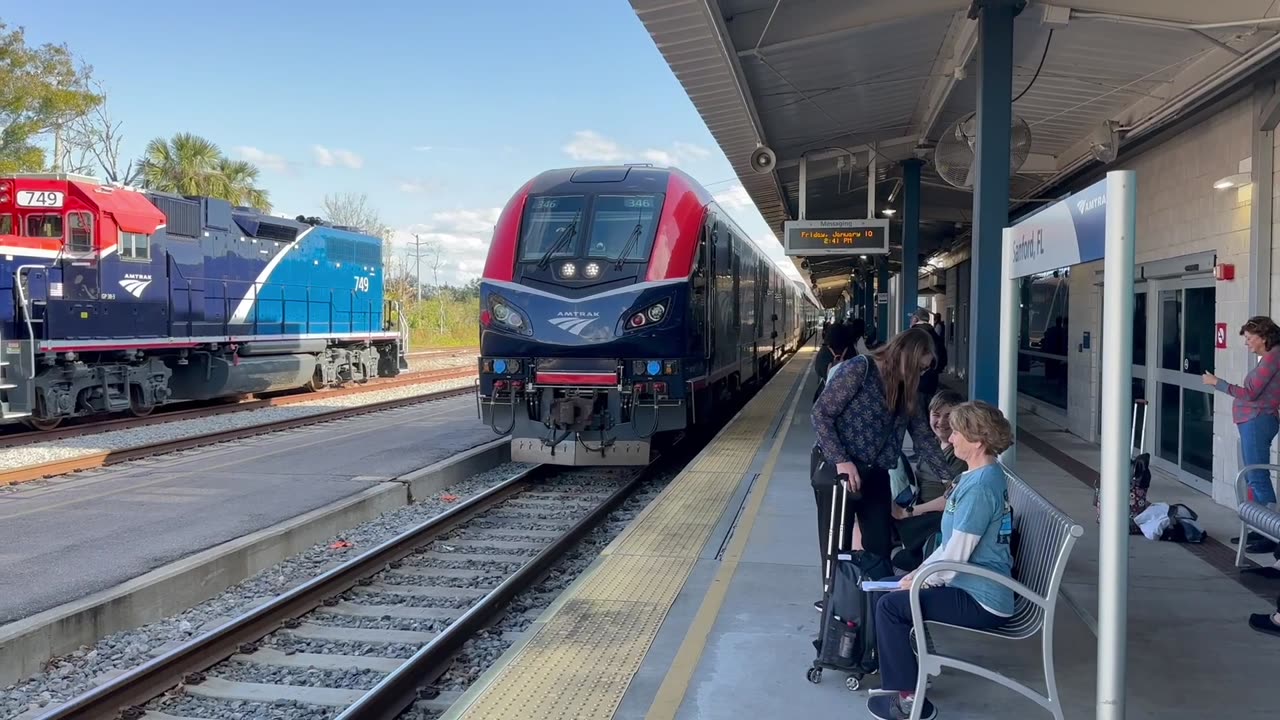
0, 448, 677, 720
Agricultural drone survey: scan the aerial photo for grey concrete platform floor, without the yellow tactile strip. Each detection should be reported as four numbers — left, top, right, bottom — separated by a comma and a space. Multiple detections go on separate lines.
627, 366, 1280, 720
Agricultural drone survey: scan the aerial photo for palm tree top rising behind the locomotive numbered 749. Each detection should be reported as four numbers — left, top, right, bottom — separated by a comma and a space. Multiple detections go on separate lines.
142, 132, 271, 213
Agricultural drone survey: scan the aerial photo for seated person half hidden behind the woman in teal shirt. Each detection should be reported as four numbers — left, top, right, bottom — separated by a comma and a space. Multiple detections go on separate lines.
892, 389, 966, 570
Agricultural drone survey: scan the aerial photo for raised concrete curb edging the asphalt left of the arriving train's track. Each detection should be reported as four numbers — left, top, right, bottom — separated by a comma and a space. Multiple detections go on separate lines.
0, 438, 511, 688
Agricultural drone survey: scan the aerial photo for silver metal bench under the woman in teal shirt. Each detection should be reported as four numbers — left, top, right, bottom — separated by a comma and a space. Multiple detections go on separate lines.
911, 464, 1084, 720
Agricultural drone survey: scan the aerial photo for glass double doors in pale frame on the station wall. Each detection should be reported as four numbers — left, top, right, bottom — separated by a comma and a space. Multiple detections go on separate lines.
1157, 279, 1216, 493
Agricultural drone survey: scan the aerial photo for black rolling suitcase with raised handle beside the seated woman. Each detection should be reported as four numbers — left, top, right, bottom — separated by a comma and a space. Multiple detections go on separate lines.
806, 482, 893, 691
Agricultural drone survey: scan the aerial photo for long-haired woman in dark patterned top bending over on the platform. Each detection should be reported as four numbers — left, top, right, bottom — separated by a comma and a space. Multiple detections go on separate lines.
810, 328, 950, 561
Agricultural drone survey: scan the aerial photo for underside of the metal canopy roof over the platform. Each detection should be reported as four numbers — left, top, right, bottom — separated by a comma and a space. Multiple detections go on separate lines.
631, 0, 1280, 305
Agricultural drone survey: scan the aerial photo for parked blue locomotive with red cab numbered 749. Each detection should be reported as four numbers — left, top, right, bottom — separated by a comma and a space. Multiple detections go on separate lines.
0, 174, 404, 428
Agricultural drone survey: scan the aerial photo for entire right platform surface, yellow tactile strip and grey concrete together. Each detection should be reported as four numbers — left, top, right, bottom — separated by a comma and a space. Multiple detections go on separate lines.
443, 350, 1280, 720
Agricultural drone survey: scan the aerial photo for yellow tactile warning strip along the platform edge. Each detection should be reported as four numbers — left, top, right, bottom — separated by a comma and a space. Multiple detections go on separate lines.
457, 348, 812, 720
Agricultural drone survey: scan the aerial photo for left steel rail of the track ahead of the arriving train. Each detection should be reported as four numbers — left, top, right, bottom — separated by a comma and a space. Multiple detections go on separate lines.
38, 465, 545, 720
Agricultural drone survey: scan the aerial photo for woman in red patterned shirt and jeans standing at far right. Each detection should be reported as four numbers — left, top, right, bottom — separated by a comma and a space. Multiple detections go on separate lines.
1203, 315, 1280, 553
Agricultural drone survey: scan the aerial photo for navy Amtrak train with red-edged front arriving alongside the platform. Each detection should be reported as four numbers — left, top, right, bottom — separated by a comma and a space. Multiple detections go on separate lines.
477, 165, 819, 465
